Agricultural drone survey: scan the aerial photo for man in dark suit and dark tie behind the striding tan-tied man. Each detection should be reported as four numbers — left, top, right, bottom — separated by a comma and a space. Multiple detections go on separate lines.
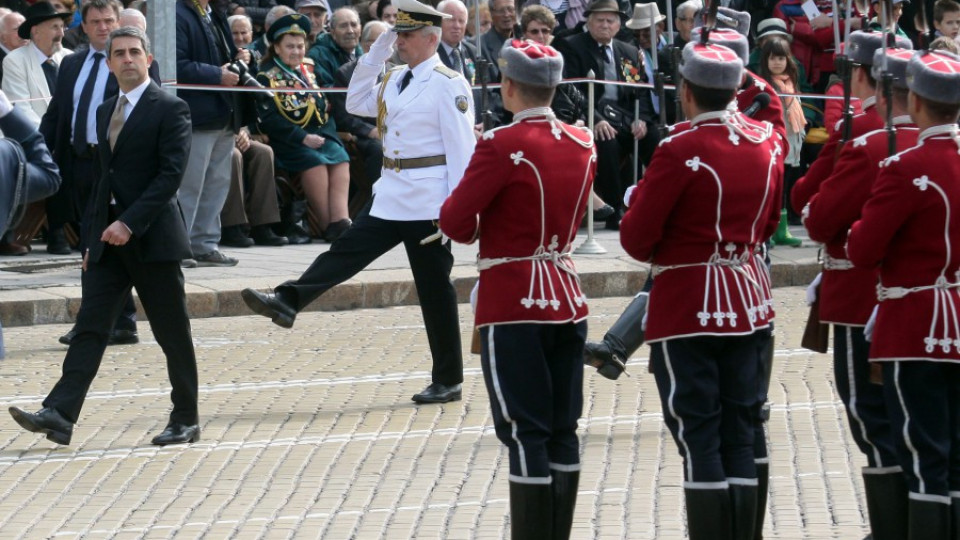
40, 0, 142, 345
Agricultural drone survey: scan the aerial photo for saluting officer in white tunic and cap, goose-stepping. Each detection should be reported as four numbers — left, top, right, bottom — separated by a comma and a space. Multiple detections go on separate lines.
243, 0, 476, 403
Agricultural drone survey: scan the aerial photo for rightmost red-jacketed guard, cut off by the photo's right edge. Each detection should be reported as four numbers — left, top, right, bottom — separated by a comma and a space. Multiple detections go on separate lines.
847, 51, 960, 540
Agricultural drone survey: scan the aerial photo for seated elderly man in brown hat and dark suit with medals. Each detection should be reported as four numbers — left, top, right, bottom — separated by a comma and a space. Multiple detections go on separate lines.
555, 0, 658, 229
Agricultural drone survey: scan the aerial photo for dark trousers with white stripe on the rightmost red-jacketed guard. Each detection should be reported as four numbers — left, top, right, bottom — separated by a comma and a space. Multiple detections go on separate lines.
883, 361, 960, 504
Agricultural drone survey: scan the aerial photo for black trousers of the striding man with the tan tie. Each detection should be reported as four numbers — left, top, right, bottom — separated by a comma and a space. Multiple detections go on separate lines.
43, 245, 198, 424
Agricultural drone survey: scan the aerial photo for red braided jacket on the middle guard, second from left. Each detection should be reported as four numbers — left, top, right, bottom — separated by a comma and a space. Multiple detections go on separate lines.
620, 110, 785, 342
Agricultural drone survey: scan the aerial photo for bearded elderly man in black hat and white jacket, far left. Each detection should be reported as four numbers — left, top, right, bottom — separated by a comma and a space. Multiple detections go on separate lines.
2, 2, 73, 127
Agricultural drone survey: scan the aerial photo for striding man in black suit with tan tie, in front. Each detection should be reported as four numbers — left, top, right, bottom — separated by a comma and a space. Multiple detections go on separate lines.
10, 27, 200, 445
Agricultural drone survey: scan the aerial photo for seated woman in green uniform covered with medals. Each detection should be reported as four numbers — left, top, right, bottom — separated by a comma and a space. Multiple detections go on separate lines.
257, 14, 350, 242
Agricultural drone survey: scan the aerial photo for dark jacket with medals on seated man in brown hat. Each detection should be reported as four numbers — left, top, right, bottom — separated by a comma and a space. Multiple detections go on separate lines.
554, 32, 656, 123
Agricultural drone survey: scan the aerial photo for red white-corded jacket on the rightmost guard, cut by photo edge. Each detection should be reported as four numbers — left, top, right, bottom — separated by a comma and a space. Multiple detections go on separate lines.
847, 124, 960, 362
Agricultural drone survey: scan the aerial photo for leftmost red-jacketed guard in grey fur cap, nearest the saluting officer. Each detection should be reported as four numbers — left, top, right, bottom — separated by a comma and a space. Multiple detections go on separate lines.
440, 40, 596, 539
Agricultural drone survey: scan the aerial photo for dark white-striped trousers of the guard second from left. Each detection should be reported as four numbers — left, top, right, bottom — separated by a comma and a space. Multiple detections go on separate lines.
650, 329, 770, 488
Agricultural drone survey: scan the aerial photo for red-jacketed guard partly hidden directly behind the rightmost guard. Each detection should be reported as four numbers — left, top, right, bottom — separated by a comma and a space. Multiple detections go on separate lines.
804, 43, 919, 540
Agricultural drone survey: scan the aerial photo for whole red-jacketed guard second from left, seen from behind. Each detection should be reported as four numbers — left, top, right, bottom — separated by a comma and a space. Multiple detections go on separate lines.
620, 42, 783, 540
